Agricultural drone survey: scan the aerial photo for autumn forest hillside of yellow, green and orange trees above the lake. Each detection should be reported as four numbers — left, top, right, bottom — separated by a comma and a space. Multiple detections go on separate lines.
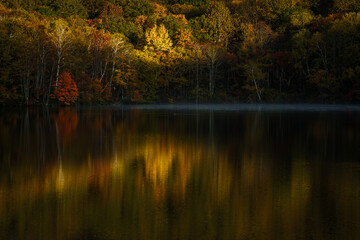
0, 0, 360, 105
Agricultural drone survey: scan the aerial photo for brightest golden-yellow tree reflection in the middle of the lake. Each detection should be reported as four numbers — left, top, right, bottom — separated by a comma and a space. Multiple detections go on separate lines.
130, 131, 200, 200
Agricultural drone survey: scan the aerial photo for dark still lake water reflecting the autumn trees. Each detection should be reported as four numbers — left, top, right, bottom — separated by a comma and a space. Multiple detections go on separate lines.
0, 106, 360, 240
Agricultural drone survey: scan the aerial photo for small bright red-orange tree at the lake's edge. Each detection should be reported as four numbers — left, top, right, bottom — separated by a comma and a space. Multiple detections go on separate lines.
52, 72, 79, 105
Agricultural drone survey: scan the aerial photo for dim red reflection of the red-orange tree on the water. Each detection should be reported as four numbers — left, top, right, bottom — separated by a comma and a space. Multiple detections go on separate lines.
56, 109, 79, 142
